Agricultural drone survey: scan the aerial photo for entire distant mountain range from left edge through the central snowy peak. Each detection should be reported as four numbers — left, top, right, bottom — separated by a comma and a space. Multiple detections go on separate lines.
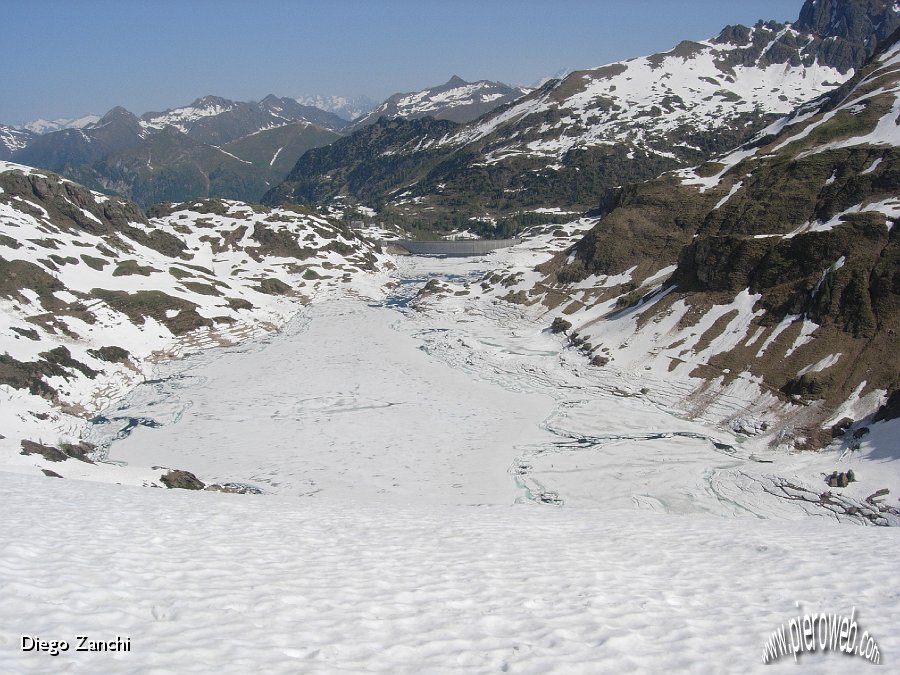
0, 78, 524, 207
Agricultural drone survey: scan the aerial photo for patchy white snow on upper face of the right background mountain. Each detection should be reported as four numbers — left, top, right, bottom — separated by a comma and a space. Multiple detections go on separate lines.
441, 21, 852, 163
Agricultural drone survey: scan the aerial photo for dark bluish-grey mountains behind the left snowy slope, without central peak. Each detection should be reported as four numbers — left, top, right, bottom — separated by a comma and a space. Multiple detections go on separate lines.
12, 97, 338, 207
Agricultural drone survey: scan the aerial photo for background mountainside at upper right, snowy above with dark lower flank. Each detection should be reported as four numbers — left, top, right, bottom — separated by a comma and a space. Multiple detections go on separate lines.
268, 0, 900, 226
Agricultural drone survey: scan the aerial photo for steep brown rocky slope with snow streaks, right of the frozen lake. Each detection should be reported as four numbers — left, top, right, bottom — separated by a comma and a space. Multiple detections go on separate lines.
472, 26, 900, 447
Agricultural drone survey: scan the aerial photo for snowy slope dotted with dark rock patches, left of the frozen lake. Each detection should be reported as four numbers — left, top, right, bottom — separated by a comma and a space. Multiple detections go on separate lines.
0, 163, 383, 492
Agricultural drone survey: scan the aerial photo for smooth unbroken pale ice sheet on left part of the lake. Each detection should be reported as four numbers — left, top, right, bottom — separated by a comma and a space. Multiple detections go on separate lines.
88, 256, 553, 504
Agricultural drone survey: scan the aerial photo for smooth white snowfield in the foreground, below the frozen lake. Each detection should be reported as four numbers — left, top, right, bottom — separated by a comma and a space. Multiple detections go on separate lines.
0, 474, 900, 675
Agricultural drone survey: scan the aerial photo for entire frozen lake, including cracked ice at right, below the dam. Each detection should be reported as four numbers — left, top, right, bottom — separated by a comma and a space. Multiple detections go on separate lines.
86, 257, 884, 518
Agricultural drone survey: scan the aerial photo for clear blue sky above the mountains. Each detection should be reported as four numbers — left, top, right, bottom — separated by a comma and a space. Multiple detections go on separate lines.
0, 0, 803, 124
